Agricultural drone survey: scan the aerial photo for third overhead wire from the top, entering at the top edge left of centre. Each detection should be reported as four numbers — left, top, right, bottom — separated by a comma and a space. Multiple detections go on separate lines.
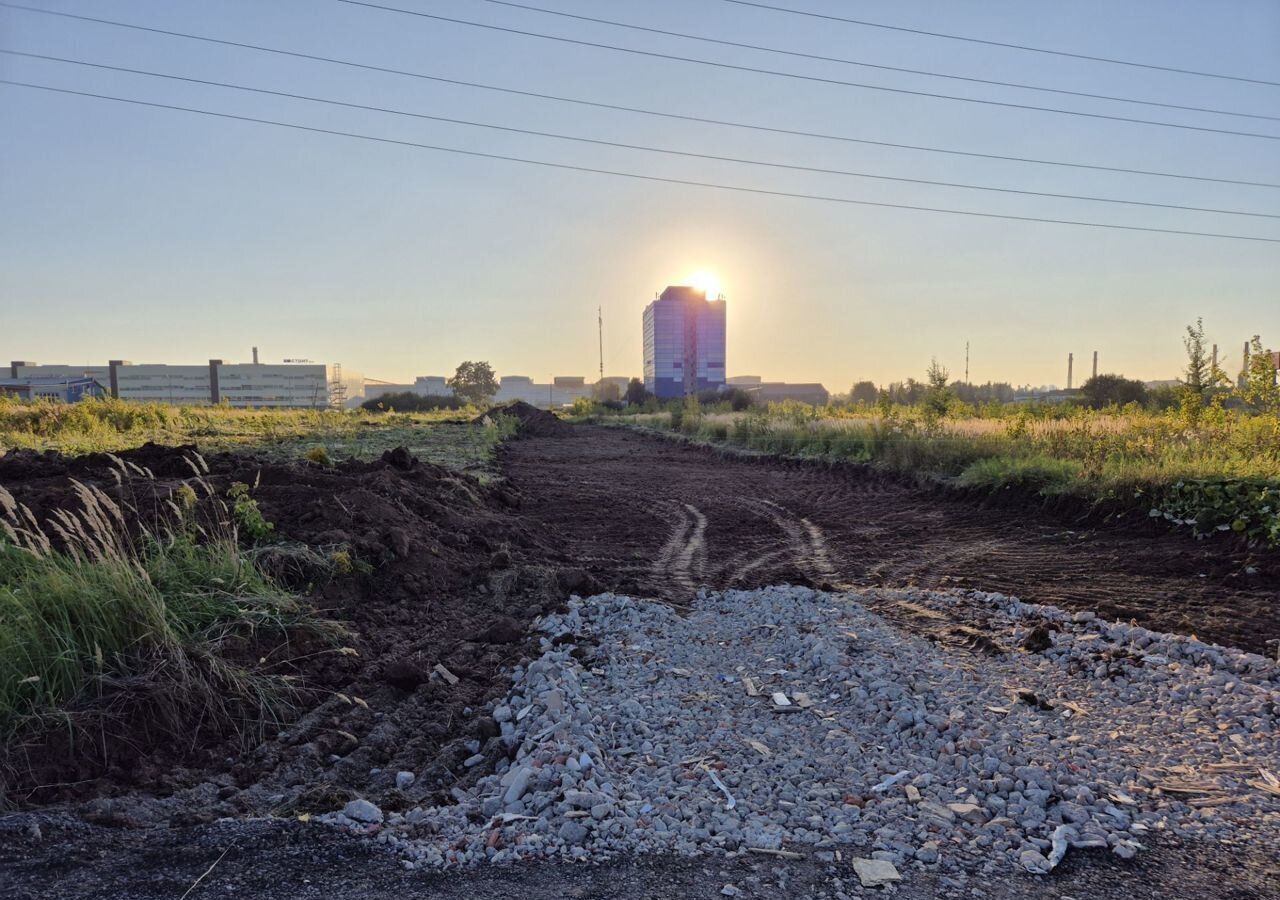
338, 0, 1280, 141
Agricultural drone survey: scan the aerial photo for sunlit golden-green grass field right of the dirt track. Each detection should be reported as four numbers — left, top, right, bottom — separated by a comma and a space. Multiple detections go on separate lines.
619, 403, 1280, 545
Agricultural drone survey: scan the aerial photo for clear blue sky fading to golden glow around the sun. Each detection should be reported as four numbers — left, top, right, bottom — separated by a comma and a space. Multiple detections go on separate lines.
0, 0, 1280, 390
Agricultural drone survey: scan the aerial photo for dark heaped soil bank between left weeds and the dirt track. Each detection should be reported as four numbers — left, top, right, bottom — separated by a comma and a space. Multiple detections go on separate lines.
0, 446, 581, 823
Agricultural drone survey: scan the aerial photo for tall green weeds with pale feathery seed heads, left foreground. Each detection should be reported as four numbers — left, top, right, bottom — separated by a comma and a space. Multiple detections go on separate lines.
0, 461, 343, 766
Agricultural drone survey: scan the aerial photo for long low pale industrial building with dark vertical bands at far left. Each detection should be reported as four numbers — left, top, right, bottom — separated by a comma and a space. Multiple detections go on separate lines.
8, 358, 343, 408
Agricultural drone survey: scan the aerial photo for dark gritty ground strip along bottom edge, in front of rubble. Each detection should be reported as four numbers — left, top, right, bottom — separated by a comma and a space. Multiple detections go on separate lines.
0, 818, 1280, 900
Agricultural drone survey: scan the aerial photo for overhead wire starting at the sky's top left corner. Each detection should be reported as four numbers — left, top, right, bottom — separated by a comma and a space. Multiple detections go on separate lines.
0, 0, 1280, 189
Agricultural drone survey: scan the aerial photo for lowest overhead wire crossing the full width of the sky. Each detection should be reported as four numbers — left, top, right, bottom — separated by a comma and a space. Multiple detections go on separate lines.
0, 78, 1280, 243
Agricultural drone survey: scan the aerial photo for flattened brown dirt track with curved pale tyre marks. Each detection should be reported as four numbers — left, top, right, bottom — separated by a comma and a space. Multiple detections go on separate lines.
503, 428, 1280, 653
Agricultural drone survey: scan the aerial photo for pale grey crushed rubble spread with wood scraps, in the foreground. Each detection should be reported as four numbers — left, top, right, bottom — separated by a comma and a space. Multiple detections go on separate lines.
317, 586, 1280, 874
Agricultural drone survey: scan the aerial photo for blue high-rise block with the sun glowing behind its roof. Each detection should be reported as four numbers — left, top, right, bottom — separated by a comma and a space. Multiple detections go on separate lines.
644, 285, 726, 399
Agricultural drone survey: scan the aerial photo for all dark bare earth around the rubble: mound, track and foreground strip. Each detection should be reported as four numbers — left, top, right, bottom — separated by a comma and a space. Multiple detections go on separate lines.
0, 428, 1280, 900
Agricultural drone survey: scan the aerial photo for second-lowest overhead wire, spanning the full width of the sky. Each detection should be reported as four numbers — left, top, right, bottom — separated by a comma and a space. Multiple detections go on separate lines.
0, 47, 1280, 219
